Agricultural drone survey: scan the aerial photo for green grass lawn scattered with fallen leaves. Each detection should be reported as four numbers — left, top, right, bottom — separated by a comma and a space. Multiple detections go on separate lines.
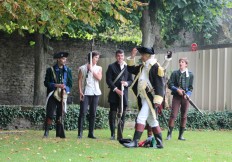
0, 129, 232, 162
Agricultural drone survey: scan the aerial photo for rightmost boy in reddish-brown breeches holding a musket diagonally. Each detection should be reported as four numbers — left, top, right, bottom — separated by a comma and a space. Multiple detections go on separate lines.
167, 57, 194, 141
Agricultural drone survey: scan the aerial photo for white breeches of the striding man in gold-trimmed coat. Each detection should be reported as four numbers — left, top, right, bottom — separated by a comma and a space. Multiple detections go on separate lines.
136, 98, 159, 127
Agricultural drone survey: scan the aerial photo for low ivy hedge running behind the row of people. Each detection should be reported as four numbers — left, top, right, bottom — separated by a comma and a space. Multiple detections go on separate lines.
0, 105, 232, 130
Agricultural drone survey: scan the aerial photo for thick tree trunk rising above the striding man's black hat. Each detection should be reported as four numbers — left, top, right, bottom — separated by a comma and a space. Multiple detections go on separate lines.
140, 1, 165, 49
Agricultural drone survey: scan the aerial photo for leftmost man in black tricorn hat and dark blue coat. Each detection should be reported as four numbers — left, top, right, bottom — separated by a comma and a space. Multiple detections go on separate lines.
44, 52, 72, 138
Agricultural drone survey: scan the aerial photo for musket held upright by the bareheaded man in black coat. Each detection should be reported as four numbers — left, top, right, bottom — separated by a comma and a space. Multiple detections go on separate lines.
117, 84, 124, 140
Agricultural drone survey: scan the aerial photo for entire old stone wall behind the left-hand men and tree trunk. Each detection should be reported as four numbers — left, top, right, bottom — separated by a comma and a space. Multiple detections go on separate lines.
0, 33, 134, 105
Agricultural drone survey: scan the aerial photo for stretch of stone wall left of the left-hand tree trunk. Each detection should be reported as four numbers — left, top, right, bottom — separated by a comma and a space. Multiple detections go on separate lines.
0, 34, 34, 104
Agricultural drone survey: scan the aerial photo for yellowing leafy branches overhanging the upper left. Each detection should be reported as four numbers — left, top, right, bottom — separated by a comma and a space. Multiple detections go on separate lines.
0, 0, 144, 37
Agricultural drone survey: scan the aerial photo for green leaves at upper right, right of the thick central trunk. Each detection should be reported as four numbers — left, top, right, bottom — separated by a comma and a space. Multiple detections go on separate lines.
154, 0, 226, 44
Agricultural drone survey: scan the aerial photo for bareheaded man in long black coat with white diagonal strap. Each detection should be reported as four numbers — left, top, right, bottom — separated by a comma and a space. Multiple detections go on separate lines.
106, 49, 133, 140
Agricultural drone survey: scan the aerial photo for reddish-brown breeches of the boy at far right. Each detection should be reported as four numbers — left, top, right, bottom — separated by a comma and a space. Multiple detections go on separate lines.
169, 96, 189, 127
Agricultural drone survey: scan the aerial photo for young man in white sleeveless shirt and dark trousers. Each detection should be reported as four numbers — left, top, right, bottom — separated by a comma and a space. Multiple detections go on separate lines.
78, 51, 102, 139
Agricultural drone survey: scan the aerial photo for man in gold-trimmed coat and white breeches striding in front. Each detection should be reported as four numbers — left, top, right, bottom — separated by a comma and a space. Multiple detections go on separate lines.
123, 47, 164, 148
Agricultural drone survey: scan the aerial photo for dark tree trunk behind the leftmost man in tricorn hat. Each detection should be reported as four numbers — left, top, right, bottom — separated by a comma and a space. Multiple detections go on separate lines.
33, 33, 46, 105
